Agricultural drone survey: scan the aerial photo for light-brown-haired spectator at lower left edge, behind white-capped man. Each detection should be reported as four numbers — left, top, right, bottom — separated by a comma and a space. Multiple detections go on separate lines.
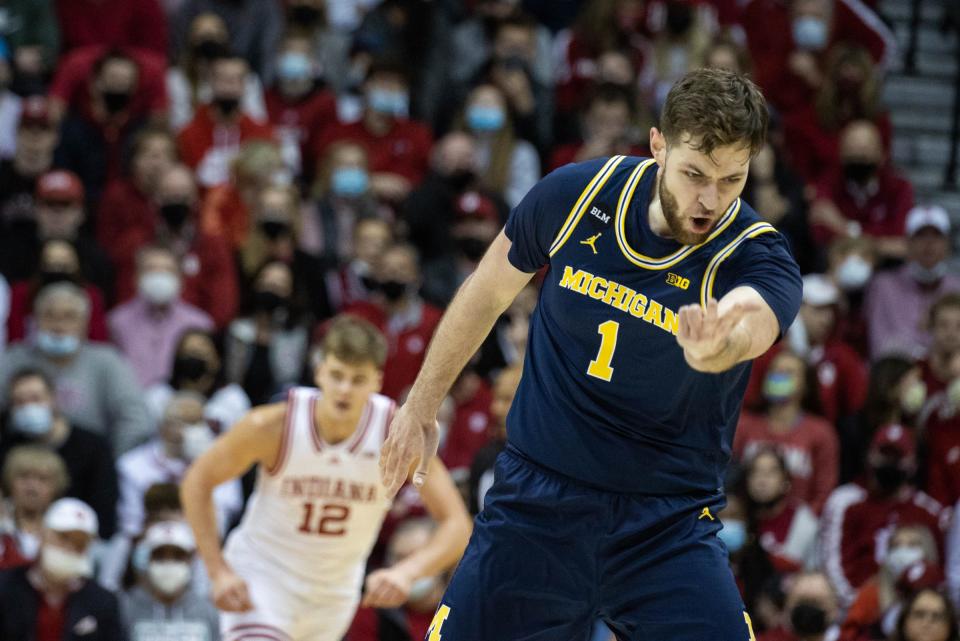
0, 445, 70, 568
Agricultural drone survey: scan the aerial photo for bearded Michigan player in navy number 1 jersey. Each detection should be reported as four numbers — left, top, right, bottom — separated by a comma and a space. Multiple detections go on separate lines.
380, 69, 801, 641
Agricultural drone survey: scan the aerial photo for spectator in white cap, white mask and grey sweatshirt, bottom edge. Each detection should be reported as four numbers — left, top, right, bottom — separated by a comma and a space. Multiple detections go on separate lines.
120, 521, 220, 641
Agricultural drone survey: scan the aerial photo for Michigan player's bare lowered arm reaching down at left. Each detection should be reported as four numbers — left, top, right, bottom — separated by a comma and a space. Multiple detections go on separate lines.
380, 231, 533, 496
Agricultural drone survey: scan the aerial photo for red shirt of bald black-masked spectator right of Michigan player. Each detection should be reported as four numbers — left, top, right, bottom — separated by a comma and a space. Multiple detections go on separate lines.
812, 167, 914, 245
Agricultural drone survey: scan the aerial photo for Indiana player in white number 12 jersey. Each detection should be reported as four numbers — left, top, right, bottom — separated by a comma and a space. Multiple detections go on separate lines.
181, 317, 471, 641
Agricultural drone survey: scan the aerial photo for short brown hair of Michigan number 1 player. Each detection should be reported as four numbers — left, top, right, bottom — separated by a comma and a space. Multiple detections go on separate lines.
660, 69, 770, 157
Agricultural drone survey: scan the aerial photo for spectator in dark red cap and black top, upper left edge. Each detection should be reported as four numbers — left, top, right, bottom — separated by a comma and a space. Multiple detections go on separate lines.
0, 96, 59, 225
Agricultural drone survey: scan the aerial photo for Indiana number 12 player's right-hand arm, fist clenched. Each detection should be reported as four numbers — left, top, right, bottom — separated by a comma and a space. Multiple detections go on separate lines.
363, 457, 473, 608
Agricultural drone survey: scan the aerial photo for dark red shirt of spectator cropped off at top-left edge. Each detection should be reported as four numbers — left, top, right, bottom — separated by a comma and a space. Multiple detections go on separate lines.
56, 0, 167, 56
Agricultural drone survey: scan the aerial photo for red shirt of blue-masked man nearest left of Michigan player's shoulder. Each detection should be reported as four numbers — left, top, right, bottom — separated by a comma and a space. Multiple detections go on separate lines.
312, 118, 433, 185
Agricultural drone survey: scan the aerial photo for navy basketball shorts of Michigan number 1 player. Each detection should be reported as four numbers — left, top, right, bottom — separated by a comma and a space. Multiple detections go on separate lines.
426, 446, 754, 641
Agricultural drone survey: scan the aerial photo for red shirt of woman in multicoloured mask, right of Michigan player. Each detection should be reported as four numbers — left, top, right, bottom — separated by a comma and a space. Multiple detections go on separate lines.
733, 412, 839, 514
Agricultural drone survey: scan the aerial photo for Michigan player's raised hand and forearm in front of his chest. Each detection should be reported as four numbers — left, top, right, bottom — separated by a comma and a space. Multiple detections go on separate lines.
677, 286, 780, 373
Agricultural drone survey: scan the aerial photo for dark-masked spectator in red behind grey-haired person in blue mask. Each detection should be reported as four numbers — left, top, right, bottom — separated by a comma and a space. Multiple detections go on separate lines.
7, 239, 108, 342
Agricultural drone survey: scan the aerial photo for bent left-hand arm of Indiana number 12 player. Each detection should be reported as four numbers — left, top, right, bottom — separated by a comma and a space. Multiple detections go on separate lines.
180, 403, 286, 612
